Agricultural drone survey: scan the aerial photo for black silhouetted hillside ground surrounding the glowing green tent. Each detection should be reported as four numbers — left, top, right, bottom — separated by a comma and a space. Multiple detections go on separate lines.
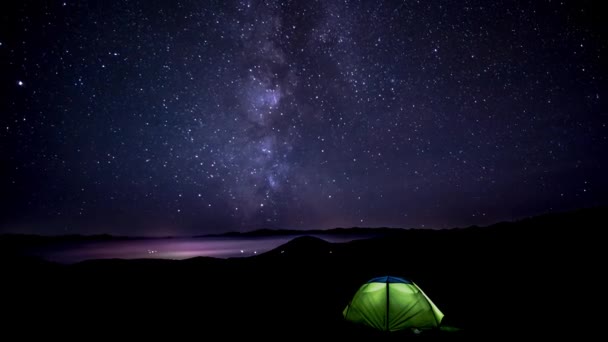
0, 208, 608, 341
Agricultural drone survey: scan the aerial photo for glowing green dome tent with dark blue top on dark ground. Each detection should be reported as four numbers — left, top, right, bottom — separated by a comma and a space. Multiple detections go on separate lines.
342, 276, 443, 331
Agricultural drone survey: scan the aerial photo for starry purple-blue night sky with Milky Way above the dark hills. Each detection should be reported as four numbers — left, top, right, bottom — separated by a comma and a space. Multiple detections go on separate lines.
0, 0, 608, 235
